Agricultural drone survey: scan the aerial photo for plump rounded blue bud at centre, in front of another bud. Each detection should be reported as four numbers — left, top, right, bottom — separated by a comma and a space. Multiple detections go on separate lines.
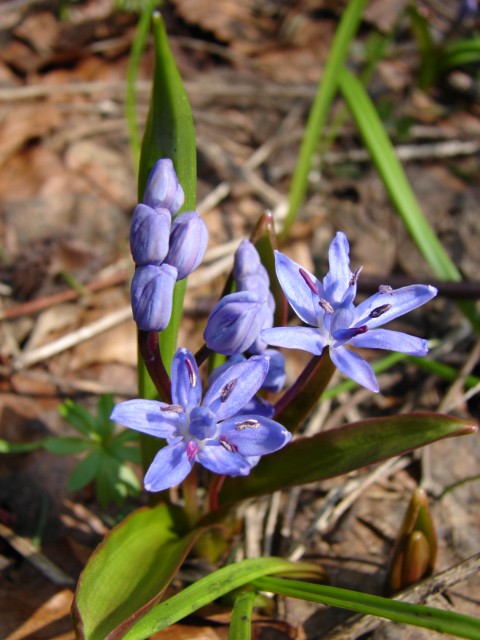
203, 291, 265, 356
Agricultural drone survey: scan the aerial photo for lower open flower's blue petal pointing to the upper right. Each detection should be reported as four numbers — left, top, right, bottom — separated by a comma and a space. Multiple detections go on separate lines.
202, 356, 269, 421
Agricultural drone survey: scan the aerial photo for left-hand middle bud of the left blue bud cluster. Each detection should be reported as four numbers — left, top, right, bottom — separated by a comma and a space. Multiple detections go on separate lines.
130, 204, 171, 266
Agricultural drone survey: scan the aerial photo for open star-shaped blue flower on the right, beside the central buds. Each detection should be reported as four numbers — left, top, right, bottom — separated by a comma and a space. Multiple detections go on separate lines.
261, 232, 437, 391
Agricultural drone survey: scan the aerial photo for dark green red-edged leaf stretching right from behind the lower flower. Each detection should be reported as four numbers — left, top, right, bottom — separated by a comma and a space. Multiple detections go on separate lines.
219, 413, 478, 505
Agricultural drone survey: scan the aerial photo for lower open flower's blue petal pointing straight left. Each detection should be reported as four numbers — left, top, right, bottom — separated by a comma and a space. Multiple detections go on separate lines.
110, 400, 186, 438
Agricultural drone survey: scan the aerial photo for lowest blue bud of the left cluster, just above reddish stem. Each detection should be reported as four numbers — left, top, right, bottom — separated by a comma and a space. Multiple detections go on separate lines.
131, 264, 177, 331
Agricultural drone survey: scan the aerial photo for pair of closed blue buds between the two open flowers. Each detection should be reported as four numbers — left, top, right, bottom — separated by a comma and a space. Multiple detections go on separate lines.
203, 240, 275, 356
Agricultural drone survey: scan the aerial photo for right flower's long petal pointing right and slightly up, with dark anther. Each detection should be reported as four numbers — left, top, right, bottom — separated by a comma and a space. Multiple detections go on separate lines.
355, 284, 437, 329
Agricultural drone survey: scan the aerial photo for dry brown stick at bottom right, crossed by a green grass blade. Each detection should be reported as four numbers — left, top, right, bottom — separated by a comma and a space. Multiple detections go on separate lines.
323, 553, 480, 640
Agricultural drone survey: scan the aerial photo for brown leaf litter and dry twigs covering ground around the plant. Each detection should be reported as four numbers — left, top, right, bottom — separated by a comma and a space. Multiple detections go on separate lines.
0, 0, 480, 640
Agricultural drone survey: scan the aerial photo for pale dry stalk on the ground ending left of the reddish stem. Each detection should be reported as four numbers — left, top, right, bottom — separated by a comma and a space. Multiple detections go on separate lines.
13, 306, 132, 371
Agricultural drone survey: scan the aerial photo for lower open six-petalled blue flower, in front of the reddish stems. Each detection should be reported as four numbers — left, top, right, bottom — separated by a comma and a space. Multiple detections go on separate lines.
111, 349, 291, 491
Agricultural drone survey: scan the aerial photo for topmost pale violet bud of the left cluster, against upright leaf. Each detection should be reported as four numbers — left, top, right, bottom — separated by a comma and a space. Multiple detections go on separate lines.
143, 158, 185, 214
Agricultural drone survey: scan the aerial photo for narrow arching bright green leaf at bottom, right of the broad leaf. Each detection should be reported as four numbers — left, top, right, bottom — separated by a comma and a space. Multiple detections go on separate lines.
122, 558, 318, 640
